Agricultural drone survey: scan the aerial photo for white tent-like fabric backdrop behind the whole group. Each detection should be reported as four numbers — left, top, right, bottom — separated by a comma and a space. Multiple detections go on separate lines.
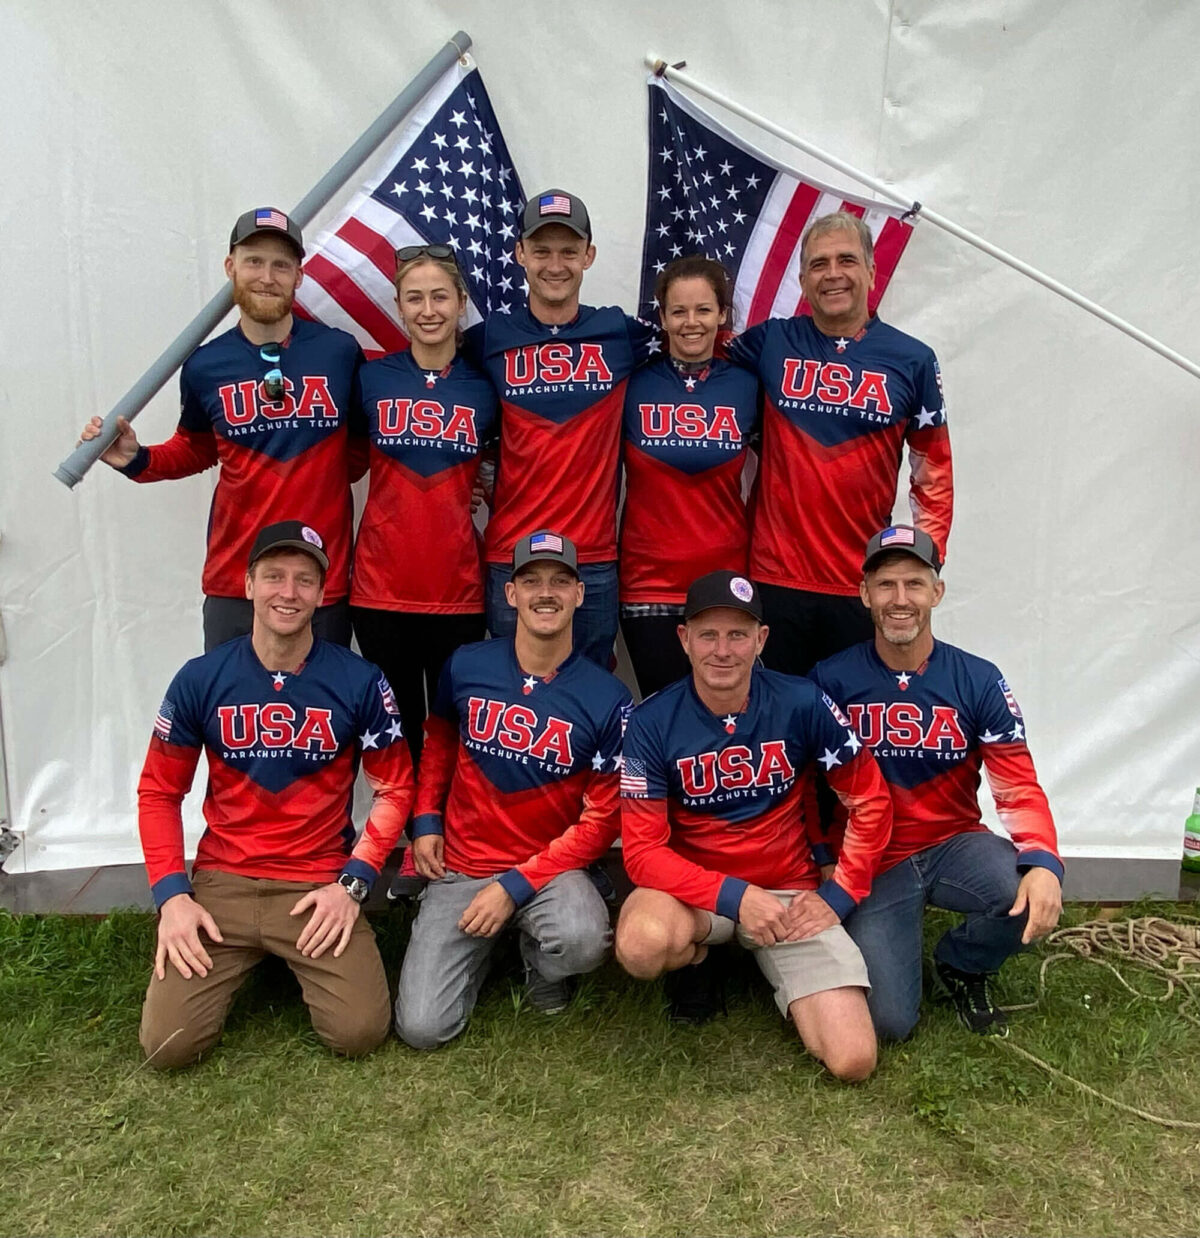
0, 0, 1200, 873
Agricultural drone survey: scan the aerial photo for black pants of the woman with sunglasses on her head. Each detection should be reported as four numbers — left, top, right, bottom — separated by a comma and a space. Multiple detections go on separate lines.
350, 607, 484, 763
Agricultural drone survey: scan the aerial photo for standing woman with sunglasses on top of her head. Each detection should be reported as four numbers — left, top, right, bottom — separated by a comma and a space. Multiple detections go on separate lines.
350, 245, 498, 760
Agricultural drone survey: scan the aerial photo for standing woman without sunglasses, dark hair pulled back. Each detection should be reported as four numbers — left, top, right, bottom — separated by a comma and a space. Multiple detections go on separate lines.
619, 255, 759, 697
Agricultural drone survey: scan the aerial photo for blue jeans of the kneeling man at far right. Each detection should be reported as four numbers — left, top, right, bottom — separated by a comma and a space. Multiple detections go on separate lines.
846, 831, 1028, 1040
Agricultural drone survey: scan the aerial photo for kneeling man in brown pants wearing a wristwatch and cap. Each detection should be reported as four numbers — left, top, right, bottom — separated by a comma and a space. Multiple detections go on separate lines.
137, 520, 412, 1067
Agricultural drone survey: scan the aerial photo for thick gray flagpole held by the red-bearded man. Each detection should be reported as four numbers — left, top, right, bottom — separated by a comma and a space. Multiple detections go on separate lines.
54, 30, 471, 489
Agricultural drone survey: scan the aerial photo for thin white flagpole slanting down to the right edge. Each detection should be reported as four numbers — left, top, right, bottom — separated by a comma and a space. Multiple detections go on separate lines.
645, 52, 1200, 379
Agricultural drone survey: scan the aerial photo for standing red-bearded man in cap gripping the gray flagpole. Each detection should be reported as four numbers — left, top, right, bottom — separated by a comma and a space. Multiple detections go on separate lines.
83, 207, 362, 650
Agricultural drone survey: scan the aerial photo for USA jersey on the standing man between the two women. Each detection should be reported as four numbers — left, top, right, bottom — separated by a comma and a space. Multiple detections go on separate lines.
463, 305, 659, 563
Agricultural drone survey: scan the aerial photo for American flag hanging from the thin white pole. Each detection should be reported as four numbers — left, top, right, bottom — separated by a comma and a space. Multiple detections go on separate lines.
640, 78, 913, 331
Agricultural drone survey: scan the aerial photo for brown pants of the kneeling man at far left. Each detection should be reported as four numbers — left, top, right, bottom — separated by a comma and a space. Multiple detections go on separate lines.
140, 869, 391, 1068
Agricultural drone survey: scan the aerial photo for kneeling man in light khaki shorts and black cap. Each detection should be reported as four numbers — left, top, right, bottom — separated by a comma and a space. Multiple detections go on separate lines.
617, 572, 892, 1081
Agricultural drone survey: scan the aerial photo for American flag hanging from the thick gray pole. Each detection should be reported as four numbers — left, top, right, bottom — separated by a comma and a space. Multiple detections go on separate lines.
296, 57, 525, 357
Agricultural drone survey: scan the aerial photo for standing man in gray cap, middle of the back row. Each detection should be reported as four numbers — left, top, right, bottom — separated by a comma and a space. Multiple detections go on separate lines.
464, 189, 658, 669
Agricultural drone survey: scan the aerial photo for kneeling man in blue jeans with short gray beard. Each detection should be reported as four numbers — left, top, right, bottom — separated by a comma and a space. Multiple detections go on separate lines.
812, 525, 1063, 1040
